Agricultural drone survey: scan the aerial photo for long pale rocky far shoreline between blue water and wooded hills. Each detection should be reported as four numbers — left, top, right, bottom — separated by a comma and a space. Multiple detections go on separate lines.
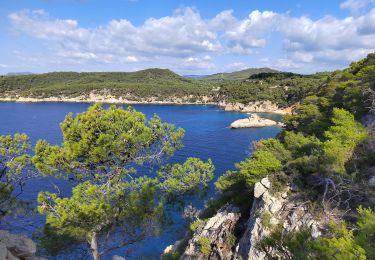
0, 95, 291, 115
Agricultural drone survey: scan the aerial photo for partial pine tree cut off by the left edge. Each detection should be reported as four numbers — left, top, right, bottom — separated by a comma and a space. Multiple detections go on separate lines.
0, 134, 34, 221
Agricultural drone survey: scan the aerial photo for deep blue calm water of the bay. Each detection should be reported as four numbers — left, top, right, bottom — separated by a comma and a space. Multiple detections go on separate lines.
0, 102, 280, 259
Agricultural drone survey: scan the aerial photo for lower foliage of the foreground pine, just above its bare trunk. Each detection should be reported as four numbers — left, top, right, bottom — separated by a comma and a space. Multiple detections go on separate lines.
38, 177, 162, 241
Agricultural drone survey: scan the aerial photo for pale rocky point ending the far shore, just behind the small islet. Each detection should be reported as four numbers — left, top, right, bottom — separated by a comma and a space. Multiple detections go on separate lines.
218, 101, 292, 114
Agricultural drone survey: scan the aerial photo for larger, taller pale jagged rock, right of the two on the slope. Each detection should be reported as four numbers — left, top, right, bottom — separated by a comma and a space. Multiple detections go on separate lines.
233, 178, 320, 260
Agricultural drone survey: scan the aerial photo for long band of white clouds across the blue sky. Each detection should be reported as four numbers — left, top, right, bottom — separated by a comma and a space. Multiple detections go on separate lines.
8, 6, 375, 71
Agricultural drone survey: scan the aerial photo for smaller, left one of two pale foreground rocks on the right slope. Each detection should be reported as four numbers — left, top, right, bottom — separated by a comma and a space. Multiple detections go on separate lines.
180, 205, 240, 260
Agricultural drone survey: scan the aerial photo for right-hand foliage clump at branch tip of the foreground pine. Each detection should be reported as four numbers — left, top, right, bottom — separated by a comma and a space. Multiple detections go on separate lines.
158, 157, 215, 197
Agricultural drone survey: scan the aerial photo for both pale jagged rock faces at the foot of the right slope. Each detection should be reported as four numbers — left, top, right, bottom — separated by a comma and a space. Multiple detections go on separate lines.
180, 178, 321, 260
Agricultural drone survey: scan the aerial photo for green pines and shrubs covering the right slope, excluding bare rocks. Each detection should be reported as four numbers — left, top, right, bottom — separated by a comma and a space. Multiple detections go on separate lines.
215, 54, 375, 259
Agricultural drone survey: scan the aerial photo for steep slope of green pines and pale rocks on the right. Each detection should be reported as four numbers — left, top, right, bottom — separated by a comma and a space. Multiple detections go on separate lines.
166, 53, 375, 260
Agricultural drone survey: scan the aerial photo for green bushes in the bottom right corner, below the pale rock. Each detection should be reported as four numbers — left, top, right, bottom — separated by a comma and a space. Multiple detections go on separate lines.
256, 207, 375, 259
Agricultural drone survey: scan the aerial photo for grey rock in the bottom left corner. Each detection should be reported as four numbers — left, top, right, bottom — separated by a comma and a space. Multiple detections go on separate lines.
0, 230, 44, 260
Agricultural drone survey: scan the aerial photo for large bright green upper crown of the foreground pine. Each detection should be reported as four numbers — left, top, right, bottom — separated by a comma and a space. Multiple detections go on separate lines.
33, 104, 184, 180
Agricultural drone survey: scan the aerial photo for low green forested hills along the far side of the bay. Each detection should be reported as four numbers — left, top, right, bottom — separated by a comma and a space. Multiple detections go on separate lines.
0, 68, 340, 107
